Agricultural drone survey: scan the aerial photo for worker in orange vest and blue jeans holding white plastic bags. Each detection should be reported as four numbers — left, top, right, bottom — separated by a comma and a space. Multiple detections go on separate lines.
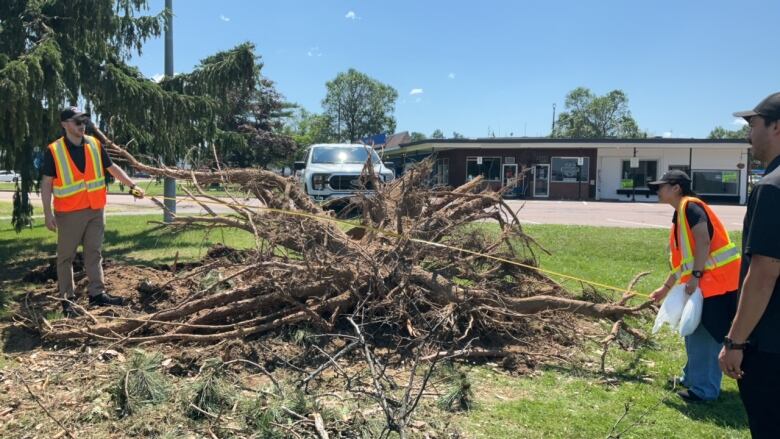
648, 170, 740, 402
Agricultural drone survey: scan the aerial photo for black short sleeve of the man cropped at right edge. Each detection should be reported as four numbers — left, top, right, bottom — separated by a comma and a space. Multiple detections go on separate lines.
742, 184, 780, 259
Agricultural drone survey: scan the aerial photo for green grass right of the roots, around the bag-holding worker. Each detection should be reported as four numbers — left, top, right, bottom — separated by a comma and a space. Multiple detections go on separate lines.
456, 225, 749, 438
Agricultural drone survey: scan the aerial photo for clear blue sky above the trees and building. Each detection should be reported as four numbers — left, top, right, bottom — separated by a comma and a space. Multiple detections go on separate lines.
132, 0, 780, 137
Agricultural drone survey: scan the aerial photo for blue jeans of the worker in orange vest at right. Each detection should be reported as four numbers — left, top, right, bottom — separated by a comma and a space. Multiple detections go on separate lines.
681, 324, 723, 401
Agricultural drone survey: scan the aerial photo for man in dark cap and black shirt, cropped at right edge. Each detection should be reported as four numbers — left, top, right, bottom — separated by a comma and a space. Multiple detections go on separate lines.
719, 93, 780, 438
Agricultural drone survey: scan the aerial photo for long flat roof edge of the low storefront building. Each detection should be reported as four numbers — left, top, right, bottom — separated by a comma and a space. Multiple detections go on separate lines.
385, 137, 750, 155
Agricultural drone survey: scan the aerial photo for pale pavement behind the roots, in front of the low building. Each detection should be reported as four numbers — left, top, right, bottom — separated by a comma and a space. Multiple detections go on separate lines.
0, 192, 745, 230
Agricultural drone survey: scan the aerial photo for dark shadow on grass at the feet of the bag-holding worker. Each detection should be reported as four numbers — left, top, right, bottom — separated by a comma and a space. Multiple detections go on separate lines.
664, 390, 748, 429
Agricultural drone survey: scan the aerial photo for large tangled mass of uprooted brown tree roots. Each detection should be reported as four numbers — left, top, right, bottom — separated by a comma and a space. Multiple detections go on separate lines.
32, 150, 644, 351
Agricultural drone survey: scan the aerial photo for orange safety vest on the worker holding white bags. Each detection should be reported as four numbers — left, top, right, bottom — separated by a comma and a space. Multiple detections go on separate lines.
669, 197, 741, 298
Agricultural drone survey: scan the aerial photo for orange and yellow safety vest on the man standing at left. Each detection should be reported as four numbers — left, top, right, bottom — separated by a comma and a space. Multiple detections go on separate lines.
49, 136, 106, 212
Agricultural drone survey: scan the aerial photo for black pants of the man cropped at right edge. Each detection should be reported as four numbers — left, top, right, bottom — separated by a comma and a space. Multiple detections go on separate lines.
738, 349, 780, 439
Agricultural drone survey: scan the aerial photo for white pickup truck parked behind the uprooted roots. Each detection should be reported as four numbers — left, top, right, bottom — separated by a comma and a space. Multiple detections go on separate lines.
295, 144, 395, 200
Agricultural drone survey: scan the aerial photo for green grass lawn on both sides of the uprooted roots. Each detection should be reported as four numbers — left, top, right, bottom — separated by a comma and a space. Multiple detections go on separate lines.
0, 217, 749, 439
